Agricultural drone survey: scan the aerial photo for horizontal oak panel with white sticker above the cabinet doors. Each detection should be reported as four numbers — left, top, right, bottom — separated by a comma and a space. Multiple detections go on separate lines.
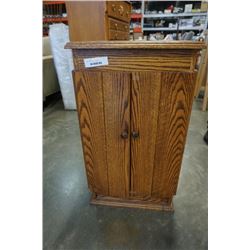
73, 49, 198, 72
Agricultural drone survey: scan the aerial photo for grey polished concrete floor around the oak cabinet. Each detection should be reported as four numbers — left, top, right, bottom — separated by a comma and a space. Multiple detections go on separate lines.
43, 98, 208, 250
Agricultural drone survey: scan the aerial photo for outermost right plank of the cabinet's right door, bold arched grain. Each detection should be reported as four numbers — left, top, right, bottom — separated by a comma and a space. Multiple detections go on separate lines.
152, 72, 195, 198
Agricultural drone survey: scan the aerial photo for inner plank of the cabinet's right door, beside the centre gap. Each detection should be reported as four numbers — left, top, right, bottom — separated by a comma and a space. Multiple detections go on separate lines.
131, 72, 161, 198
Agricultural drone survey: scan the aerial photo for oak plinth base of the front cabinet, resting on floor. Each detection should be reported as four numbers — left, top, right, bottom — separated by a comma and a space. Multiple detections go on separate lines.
90, 195, 174, 211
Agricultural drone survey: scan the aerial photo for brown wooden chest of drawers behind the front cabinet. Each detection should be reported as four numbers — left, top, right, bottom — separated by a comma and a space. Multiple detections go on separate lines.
66, 1, 131, 41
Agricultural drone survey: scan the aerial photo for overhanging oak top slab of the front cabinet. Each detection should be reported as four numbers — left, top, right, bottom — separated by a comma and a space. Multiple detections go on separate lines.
65, 41, 206, 50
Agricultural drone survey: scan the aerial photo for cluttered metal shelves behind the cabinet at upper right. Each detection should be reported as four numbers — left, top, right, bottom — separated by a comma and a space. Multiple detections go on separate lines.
130, 0, 208, 37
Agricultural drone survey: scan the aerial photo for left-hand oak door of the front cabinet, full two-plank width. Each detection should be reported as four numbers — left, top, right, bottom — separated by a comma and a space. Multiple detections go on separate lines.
74, 71, 130, 198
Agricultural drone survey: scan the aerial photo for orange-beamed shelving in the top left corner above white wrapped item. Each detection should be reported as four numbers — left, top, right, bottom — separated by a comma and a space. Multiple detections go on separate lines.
43, 1, 68, 36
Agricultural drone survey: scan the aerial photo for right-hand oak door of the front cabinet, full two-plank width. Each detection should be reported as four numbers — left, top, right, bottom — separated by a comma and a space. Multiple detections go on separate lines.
131, 72, 194, 200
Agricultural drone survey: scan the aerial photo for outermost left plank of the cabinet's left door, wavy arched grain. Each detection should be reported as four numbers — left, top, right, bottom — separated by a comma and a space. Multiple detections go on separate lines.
74, 72, 108, 195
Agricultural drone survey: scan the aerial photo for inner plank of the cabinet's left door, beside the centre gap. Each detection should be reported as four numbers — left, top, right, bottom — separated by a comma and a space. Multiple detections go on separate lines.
103, 72, 130, 197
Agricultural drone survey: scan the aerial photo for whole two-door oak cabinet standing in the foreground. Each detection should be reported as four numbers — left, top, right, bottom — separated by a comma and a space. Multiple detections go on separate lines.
66, 41, 204, 211
